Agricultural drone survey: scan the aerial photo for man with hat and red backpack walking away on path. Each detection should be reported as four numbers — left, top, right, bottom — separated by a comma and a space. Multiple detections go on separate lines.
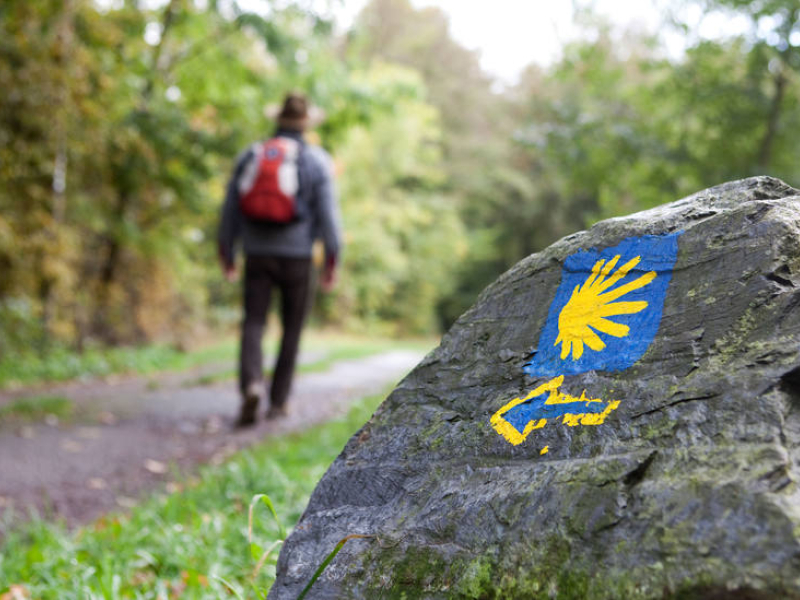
218, 92, 341, 427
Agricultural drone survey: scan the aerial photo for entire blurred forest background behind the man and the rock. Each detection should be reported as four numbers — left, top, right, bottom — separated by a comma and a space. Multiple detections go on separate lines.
0, 0, 800, 362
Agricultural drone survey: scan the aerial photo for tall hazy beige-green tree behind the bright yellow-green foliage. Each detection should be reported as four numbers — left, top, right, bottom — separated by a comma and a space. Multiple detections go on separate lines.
349, 0, 520, 327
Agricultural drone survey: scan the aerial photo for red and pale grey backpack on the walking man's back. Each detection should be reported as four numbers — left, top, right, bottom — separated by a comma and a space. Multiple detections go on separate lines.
238, 137, 302, 224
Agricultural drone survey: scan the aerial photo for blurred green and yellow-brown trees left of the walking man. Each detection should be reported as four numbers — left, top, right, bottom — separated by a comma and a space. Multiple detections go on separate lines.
0, 0, 334, 352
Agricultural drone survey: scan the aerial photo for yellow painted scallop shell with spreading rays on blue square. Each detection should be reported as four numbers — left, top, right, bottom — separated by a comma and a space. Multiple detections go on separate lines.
553, 254, 656, 360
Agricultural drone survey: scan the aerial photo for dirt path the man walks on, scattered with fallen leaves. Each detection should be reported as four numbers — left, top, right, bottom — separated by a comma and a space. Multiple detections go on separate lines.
0, 351, 422, 534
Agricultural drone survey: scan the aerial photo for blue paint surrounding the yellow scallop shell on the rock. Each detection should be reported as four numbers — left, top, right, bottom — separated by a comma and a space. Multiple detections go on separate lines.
524, 232, 682, 378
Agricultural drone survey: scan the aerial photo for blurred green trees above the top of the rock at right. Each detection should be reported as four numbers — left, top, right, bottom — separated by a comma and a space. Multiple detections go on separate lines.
510, 2, 800, 234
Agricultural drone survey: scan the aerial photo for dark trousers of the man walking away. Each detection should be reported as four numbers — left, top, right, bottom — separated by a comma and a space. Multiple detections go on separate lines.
239, 256, 311, 406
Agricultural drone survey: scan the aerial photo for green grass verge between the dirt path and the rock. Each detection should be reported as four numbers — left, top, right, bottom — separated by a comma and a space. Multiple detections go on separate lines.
0, 396, 390, 600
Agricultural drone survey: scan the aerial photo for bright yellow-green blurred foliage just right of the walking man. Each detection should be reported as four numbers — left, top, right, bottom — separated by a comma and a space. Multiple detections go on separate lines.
327, 62, 466, 333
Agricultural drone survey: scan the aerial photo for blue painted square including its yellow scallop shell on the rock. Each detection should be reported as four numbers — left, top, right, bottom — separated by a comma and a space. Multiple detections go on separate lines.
524, 232, 680, 376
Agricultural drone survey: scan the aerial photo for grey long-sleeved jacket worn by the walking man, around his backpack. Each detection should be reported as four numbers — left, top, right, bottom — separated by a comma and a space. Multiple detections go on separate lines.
217, 129, 342, 265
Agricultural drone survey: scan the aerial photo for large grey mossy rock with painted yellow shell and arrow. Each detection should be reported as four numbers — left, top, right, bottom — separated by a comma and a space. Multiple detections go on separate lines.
270, 178, 800, 599
